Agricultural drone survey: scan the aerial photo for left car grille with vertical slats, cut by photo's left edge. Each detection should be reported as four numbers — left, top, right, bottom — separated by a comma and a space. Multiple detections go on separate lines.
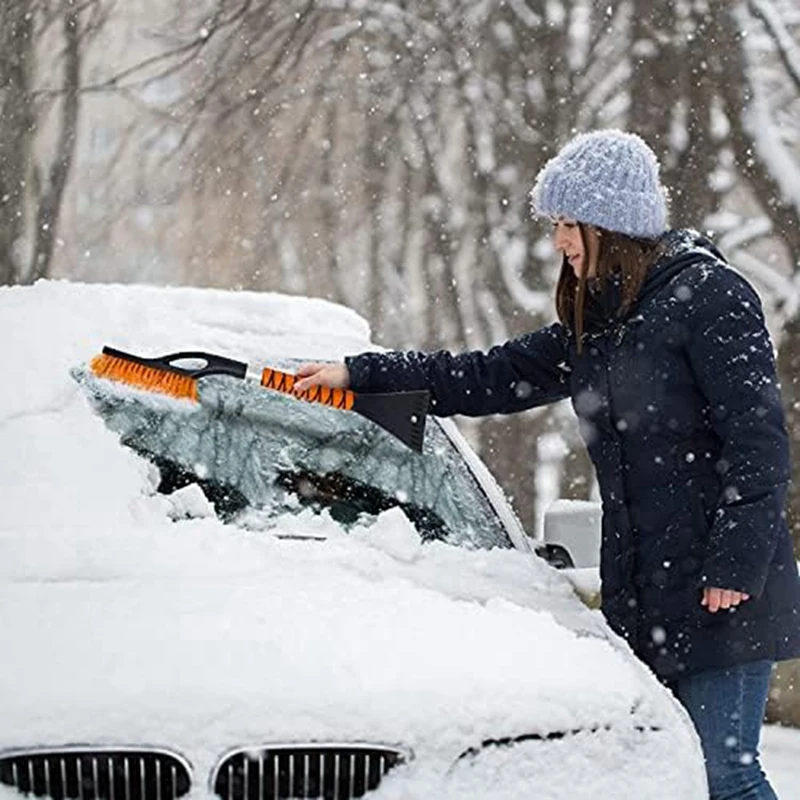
0, 747, 191, 800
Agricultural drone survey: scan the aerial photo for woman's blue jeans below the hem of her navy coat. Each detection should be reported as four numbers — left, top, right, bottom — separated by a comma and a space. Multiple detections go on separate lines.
670, 661, 777, 800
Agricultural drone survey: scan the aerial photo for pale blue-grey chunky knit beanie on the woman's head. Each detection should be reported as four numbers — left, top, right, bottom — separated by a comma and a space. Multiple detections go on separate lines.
531, 130, 667, 239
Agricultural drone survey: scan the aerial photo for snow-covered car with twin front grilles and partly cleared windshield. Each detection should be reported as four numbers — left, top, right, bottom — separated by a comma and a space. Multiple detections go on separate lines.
0, 282, 706, 800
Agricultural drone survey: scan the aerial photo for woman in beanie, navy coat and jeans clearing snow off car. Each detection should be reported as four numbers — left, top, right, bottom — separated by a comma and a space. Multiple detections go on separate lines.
297, 131, 800, 800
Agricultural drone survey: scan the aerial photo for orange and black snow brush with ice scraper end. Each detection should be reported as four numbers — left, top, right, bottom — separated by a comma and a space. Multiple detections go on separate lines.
90, 347, 430, 453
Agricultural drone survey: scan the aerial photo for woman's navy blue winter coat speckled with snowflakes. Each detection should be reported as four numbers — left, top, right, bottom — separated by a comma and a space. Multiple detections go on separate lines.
347, 231, 800, 679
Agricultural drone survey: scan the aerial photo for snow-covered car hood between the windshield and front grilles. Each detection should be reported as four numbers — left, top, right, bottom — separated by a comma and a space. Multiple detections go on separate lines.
0, 510, 680, 757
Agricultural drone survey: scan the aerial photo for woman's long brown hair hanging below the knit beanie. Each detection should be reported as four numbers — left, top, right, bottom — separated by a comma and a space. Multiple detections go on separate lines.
556, 223, 661, 353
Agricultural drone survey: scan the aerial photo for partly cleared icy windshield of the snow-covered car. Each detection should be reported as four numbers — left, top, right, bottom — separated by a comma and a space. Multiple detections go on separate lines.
76, 372, 511, 548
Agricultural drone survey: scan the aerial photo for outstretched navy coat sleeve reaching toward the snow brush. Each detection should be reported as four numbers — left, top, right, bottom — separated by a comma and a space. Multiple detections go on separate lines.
345, 323, 570, 417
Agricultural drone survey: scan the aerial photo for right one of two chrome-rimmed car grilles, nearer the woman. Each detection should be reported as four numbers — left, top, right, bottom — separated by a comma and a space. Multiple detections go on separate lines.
212, 743, 411, 800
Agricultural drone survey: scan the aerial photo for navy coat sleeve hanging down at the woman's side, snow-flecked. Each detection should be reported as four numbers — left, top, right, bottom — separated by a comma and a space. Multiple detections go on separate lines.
688, 265, 791, 597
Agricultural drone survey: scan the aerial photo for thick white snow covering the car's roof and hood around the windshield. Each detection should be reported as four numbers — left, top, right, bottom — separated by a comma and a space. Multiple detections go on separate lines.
0, 282, 688, 788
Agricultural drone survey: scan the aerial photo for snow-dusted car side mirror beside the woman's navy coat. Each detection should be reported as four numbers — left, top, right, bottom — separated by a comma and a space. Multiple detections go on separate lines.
543, 500, 602, 569
